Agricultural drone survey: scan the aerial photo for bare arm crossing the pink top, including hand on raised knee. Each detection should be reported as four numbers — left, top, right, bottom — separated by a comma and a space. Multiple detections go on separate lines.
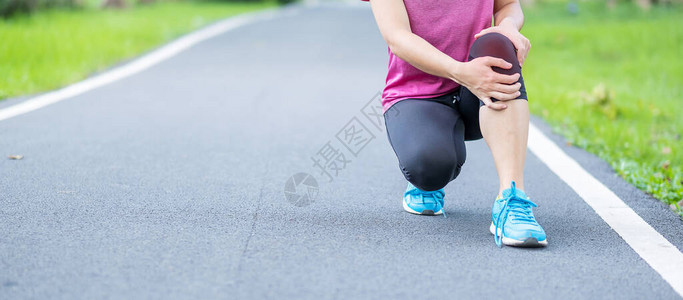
370, 0, 520, 110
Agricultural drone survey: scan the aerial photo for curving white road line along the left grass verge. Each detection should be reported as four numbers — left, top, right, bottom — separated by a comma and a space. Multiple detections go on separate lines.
0, 7, 295, 121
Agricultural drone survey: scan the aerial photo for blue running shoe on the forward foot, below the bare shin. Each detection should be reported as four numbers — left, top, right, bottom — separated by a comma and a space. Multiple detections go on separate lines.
489, 181, 548, 247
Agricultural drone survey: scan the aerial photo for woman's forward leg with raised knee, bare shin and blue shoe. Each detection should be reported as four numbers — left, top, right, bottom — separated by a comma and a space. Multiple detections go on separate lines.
459, 33, 548, 247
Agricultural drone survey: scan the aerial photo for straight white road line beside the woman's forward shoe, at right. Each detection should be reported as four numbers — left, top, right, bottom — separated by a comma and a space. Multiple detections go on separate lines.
529, 124, 683, 297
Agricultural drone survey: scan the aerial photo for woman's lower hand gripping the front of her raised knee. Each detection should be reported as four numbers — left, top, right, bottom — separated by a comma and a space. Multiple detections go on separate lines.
453, 56, 522, 110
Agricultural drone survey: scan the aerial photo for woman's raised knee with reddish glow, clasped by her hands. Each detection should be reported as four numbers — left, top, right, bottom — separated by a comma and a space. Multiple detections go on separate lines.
470, 32, 521, 75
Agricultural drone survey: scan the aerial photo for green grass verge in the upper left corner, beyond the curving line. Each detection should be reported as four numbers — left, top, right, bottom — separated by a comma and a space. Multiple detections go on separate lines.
0, 1, 276, 99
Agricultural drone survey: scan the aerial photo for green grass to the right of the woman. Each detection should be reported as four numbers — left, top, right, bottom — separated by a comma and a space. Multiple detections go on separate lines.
523, 2, 683, 216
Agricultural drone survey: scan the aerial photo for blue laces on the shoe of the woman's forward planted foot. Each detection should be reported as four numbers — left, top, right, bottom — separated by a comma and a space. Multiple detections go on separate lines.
493, 181, 538, 247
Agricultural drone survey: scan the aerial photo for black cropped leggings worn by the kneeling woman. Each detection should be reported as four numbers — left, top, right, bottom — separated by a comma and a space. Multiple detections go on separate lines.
384, 33, 527, 191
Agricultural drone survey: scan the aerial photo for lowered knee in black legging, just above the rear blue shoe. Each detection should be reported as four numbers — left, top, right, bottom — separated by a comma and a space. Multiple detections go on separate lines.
403, 149, 465, 191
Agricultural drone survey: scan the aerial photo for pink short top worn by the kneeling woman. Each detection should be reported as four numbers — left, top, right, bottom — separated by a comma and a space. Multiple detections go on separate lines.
364, 0, 493, 111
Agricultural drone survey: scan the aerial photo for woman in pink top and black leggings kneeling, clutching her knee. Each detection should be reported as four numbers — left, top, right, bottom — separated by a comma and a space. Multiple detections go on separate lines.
370, 0, 548, 247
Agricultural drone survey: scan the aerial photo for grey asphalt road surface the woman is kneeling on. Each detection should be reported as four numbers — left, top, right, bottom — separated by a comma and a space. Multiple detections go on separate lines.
0, 5, 683, 299
